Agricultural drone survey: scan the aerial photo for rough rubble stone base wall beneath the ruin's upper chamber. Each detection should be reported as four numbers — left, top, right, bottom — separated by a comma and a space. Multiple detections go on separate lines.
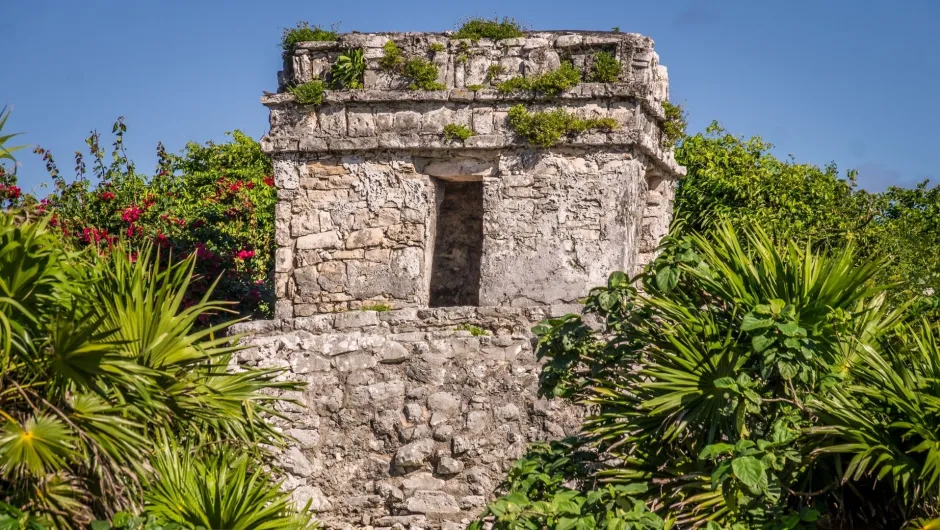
234, 306, 581, 528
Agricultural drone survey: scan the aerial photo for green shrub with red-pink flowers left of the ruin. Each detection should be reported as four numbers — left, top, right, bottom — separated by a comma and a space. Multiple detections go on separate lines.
20, 119, 276, 320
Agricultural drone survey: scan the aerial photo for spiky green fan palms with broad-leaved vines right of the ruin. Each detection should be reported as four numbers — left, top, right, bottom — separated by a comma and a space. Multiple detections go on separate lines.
476, 221, 940, 530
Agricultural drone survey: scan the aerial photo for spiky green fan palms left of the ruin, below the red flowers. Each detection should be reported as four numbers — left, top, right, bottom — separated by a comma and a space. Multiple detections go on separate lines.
0, 212, 314, 528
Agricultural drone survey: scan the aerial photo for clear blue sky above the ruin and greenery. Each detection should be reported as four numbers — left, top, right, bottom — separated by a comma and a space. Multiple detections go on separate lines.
0, 0, 940, 193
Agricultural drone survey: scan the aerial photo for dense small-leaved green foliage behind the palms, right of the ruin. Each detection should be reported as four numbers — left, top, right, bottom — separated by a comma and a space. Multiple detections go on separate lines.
676, 123, 940, 300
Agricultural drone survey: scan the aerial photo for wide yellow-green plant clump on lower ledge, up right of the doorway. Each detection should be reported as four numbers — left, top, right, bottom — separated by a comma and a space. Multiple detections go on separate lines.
509, 104, 617, 147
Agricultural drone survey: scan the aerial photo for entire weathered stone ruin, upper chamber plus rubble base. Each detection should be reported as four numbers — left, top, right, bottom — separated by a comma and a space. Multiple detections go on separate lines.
236, 31, 684, 528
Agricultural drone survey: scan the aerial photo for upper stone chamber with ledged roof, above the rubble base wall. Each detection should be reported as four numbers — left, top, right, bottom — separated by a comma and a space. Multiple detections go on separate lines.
262, 29, 681, 318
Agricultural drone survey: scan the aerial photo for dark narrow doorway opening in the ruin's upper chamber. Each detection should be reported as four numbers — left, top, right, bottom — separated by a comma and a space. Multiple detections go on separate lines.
430, 180, 483, 307
